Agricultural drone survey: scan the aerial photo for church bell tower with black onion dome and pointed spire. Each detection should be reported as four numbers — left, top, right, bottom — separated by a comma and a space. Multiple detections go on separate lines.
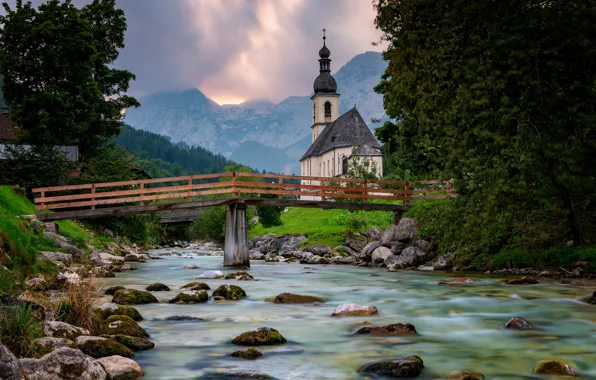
311, 29, 339, 143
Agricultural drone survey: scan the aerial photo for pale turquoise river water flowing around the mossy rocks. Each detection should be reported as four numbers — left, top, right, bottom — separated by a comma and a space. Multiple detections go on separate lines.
102, 249, 596, 380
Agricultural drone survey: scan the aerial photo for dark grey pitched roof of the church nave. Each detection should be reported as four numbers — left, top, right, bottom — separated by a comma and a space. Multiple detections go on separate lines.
300, 107, 381, 161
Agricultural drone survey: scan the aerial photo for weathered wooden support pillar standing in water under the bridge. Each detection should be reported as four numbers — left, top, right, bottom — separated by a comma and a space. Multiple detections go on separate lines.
224, 203, 250, 267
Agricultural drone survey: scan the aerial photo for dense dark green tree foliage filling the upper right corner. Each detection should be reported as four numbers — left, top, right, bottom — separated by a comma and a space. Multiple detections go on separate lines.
375, 0, 596, 244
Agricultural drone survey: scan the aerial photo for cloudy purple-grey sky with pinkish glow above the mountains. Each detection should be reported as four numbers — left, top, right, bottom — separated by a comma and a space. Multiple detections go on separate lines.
3, 0, 382, 104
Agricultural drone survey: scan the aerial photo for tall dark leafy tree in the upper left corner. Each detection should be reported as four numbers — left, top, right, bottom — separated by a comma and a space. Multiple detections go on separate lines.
0, 0, 139, 157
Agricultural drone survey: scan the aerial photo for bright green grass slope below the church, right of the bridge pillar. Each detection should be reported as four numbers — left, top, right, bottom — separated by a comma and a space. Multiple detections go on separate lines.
250, 208, 393, 247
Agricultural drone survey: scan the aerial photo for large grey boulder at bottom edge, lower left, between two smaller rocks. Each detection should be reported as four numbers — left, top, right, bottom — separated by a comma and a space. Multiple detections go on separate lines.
20, 347, 108, 380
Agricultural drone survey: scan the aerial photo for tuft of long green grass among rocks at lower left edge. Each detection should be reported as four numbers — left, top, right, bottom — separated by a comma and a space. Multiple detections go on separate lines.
0, 305, 41, 358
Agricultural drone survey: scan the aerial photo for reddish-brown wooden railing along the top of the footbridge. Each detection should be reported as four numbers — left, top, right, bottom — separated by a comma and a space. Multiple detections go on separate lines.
33, 172, 455, 211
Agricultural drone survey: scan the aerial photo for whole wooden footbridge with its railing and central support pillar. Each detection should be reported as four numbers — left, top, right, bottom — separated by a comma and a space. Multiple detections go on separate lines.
33, 172, 455, 266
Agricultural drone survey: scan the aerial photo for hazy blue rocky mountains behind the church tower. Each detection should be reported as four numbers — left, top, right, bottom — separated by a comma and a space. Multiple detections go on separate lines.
125, 52, 387, 173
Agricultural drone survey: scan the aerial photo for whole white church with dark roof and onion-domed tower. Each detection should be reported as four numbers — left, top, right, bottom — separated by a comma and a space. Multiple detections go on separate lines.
300, 30, 383, 178
